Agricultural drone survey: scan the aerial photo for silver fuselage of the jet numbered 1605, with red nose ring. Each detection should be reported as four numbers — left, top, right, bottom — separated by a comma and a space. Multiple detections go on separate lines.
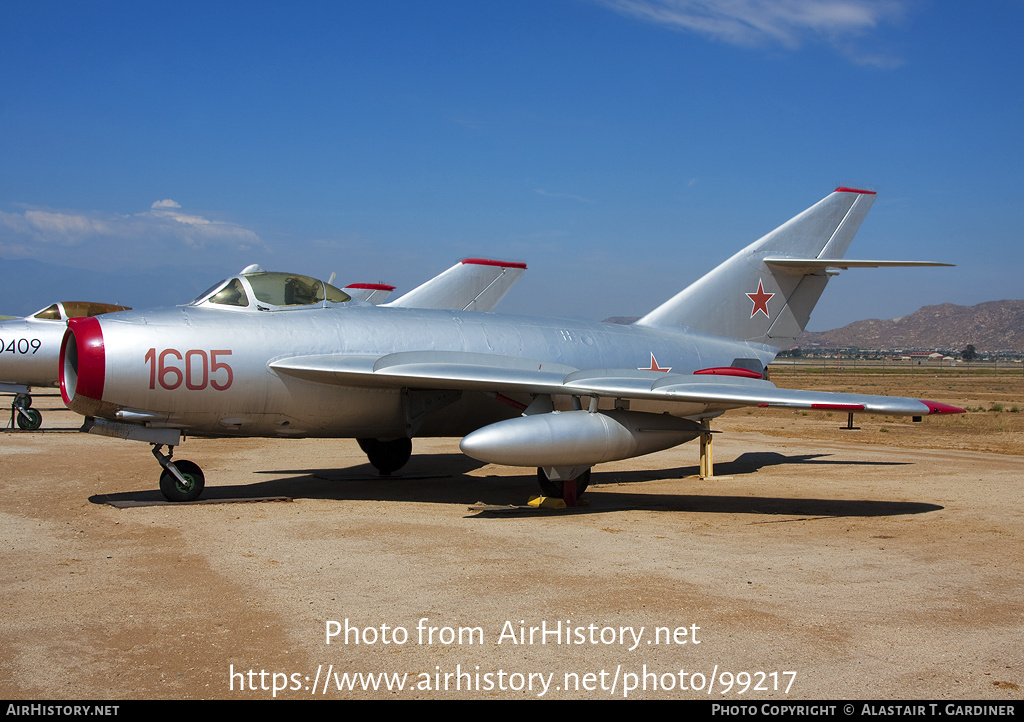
61, 304, 775, 438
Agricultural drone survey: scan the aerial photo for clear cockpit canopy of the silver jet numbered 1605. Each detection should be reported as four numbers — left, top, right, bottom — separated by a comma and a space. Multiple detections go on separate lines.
189, 266, 352, 311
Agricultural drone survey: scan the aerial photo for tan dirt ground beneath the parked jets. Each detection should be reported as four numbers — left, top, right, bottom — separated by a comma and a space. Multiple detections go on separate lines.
0, 374, 1024, 702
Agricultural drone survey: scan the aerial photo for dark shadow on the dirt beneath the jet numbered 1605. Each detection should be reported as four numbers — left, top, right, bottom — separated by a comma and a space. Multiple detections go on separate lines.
90, 452, 942, 516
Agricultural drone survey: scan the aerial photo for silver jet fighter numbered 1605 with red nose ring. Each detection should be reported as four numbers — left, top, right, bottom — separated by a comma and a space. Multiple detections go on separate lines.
60, 188, 963, 501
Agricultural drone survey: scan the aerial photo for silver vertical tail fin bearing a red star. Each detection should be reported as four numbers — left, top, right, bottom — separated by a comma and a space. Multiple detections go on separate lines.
636, 188, 874, 348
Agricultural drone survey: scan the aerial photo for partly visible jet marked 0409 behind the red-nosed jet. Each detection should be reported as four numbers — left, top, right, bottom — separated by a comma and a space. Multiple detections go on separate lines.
0, 301, 130, 431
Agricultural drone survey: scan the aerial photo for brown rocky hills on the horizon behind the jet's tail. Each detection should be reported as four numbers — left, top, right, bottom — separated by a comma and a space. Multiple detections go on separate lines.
796, 301, 1024, 351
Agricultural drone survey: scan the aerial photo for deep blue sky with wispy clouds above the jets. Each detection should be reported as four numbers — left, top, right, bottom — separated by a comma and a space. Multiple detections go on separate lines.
0, 0, 1024, 330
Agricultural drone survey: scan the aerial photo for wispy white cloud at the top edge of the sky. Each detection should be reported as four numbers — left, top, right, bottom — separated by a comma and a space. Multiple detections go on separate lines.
598, 0, 905, 65
